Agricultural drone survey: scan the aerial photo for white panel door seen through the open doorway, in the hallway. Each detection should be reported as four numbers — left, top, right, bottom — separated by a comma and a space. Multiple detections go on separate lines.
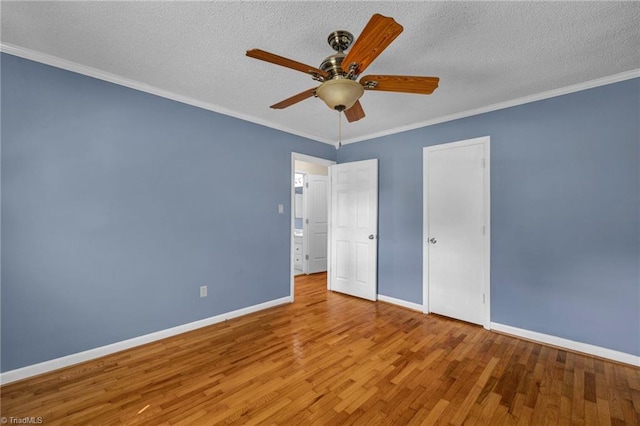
303, 175, 329, 274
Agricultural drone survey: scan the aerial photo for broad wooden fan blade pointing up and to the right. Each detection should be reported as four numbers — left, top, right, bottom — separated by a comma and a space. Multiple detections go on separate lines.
342, 13, 403, 74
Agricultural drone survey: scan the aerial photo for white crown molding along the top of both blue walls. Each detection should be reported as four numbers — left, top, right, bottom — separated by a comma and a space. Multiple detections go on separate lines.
0, 43, 640, 146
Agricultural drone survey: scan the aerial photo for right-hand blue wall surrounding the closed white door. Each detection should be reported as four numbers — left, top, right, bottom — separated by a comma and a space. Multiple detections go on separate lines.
338, 79, 640, 355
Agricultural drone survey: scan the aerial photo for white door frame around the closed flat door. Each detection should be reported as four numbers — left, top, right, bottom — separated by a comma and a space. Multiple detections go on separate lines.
422, 136, 491, 330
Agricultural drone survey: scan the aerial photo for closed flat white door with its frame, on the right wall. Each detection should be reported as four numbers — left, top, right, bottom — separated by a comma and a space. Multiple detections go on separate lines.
423, 138, 489, 327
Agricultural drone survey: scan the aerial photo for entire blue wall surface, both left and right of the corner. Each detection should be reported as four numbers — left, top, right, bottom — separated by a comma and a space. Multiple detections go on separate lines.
1, 50, 640, 371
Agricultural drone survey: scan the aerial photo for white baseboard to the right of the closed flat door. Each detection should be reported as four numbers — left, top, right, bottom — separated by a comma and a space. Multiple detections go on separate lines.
491, 322, 640, 367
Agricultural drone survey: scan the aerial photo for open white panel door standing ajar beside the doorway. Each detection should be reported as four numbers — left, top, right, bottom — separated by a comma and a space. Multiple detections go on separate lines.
329, 160, 378, 300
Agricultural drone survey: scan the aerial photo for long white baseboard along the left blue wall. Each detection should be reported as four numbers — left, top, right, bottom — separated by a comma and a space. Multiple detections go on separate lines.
0, 296, 293, 385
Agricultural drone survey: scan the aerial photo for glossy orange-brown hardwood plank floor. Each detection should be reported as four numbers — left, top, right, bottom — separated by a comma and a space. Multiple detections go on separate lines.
1, 274, 640, 426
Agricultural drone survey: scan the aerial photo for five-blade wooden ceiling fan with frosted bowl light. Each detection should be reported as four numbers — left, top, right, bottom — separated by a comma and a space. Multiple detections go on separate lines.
247, 13, 440, 122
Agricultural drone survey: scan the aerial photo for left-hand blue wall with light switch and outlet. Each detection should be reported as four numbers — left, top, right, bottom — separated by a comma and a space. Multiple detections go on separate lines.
1, 54, 336, 371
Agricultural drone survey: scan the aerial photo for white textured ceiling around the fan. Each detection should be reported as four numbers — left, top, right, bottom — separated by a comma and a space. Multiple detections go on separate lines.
0, 1, 640, 144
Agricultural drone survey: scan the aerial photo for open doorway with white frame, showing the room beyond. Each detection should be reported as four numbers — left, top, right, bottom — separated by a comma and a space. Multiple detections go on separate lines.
290, 152, 336, 300
